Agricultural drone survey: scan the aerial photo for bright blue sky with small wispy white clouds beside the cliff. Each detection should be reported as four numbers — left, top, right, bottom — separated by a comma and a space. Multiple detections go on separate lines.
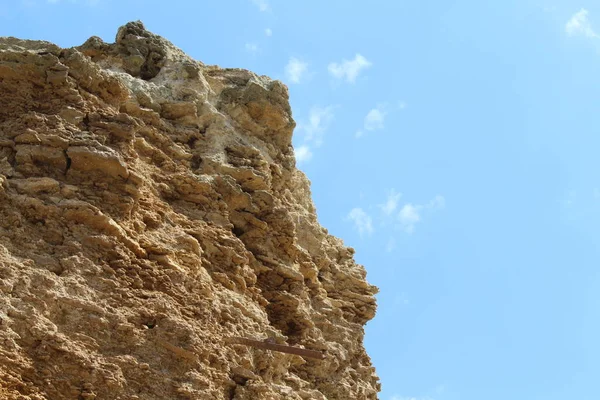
0, 0, 600, 400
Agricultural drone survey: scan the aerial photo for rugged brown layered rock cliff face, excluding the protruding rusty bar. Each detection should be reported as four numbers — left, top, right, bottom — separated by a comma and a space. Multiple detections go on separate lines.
0, 22, 379, 400
